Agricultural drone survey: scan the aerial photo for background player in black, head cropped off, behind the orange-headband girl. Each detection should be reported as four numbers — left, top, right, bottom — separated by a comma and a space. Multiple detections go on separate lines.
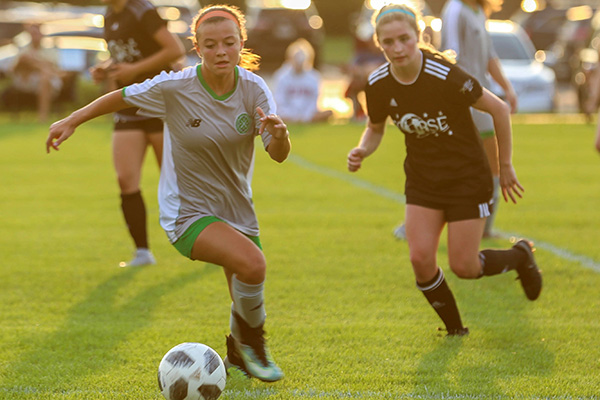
91, 0, 184, 266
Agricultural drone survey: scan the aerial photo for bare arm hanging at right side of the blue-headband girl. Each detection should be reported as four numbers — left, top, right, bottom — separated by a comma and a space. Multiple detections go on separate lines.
473, 88, 524, 203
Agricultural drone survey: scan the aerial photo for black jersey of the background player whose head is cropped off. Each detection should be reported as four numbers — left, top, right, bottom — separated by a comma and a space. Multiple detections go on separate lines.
104, 0, 169, 86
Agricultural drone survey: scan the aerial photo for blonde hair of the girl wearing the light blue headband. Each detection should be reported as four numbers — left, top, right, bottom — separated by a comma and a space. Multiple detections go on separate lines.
371, 0, 454, 63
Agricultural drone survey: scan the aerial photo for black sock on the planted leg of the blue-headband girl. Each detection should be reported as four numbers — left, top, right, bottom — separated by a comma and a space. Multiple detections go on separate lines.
417, 268, 463, 333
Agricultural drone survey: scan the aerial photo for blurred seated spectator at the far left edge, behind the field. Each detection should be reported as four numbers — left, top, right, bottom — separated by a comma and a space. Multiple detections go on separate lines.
4, 24, 63, 122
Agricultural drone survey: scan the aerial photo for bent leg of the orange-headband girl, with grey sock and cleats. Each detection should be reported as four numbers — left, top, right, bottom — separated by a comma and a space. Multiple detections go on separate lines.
191, 222, 283, 382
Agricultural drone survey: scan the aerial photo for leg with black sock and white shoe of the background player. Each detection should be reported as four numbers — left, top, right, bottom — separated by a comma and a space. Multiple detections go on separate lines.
113, 128, 156, 266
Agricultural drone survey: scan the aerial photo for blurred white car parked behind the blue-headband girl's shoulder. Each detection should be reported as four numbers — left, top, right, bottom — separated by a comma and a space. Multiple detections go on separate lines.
487, 20, 556, 113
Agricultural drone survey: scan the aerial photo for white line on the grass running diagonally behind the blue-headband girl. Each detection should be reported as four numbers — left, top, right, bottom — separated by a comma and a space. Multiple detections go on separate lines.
288, 154, 600, 273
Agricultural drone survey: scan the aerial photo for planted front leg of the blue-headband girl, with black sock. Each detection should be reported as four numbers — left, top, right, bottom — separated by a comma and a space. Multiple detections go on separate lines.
405, 204, 468, 335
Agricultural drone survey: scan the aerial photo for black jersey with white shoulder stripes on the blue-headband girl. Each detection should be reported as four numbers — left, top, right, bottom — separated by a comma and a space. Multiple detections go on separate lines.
366, 51, 493, 204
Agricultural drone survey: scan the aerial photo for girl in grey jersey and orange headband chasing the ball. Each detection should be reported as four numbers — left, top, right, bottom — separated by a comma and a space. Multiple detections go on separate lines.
46, 5, 290, 382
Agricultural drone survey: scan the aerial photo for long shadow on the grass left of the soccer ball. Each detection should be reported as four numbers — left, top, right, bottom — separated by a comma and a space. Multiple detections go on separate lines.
0, 264, 220, 397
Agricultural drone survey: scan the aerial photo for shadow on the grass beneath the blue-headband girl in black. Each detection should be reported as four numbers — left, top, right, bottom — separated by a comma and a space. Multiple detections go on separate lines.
413, 277, 555, 398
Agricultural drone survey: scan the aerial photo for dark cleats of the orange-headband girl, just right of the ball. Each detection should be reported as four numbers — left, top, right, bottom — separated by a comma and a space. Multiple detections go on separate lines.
224, 313, 283, 382
